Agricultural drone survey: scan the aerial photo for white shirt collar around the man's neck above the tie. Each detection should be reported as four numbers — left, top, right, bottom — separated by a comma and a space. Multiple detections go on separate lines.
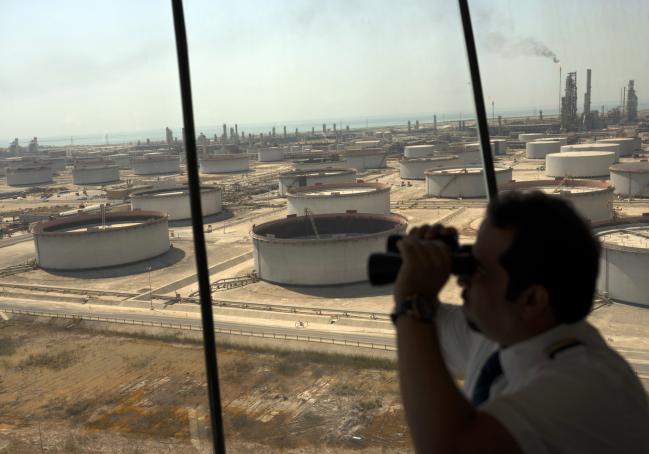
500, 320, 587, 380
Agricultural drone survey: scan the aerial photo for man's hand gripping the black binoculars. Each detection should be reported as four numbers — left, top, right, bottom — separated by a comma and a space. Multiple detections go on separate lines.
394, 224, 457, 303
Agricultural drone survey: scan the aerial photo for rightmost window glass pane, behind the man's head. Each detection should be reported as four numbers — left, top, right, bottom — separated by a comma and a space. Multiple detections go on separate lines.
471, 1, 649, 387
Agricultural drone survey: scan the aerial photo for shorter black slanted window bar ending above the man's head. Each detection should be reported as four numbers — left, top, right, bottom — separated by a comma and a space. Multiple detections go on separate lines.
458, 0, 498, 200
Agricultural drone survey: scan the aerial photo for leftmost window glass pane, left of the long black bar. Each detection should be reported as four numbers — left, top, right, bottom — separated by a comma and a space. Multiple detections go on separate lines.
0, 1, 215, 453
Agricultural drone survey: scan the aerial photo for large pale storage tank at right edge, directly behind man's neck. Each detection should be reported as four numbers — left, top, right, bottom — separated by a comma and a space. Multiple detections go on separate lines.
594, 216, 649, 306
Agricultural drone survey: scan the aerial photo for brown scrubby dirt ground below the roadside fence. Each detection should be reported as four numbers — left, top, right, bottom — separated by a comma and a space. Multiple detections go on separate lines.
0, 318, 411, 454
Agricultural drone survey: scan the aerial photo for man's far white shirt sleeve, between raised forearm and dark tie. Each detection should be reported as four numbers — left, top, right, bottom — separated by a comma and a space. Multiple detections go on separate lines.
435, 304, 477, 376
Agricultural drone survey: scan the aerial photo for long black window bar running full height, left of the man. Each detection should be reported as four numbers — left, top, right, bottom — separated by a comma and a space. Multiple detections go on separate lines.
171, 0, 225, 454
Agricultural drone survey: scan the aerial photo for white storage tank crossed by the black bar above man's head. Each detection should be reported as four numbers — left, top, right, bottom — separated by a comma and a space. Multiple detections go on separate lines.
425, 166, 512, 199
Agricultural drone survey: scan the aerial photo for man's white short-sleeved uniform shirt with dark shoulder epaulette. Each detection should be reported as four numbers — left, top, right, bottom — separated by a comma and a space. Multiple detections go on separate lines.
437, 305, 649, 454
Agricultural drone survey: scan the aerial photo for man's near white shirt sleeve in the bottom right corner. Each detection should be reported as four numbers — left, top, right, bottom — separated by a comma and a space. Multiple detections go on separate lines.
479, 358, 649, 454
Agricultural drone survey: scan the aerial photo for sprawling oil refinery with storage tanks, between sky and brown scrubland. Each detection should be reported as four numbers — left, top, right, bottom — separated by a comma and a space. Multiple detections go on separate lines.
0, 70, 649, 452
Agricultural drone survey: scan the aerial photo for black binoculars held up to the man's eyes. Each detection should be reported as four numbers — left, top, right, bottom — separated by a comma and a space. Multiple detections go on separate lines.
367, 235, 478, 285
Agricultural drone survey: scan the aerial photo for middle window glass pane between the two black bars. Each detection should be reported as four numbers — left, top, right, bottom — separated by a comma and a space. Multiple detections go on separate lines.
179, 1, 476, 452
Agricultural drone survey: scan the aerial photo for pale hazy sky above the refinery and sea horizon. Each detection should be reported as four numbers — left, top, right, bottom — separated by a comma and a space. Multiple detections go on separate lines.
0, 0, 649, 142
